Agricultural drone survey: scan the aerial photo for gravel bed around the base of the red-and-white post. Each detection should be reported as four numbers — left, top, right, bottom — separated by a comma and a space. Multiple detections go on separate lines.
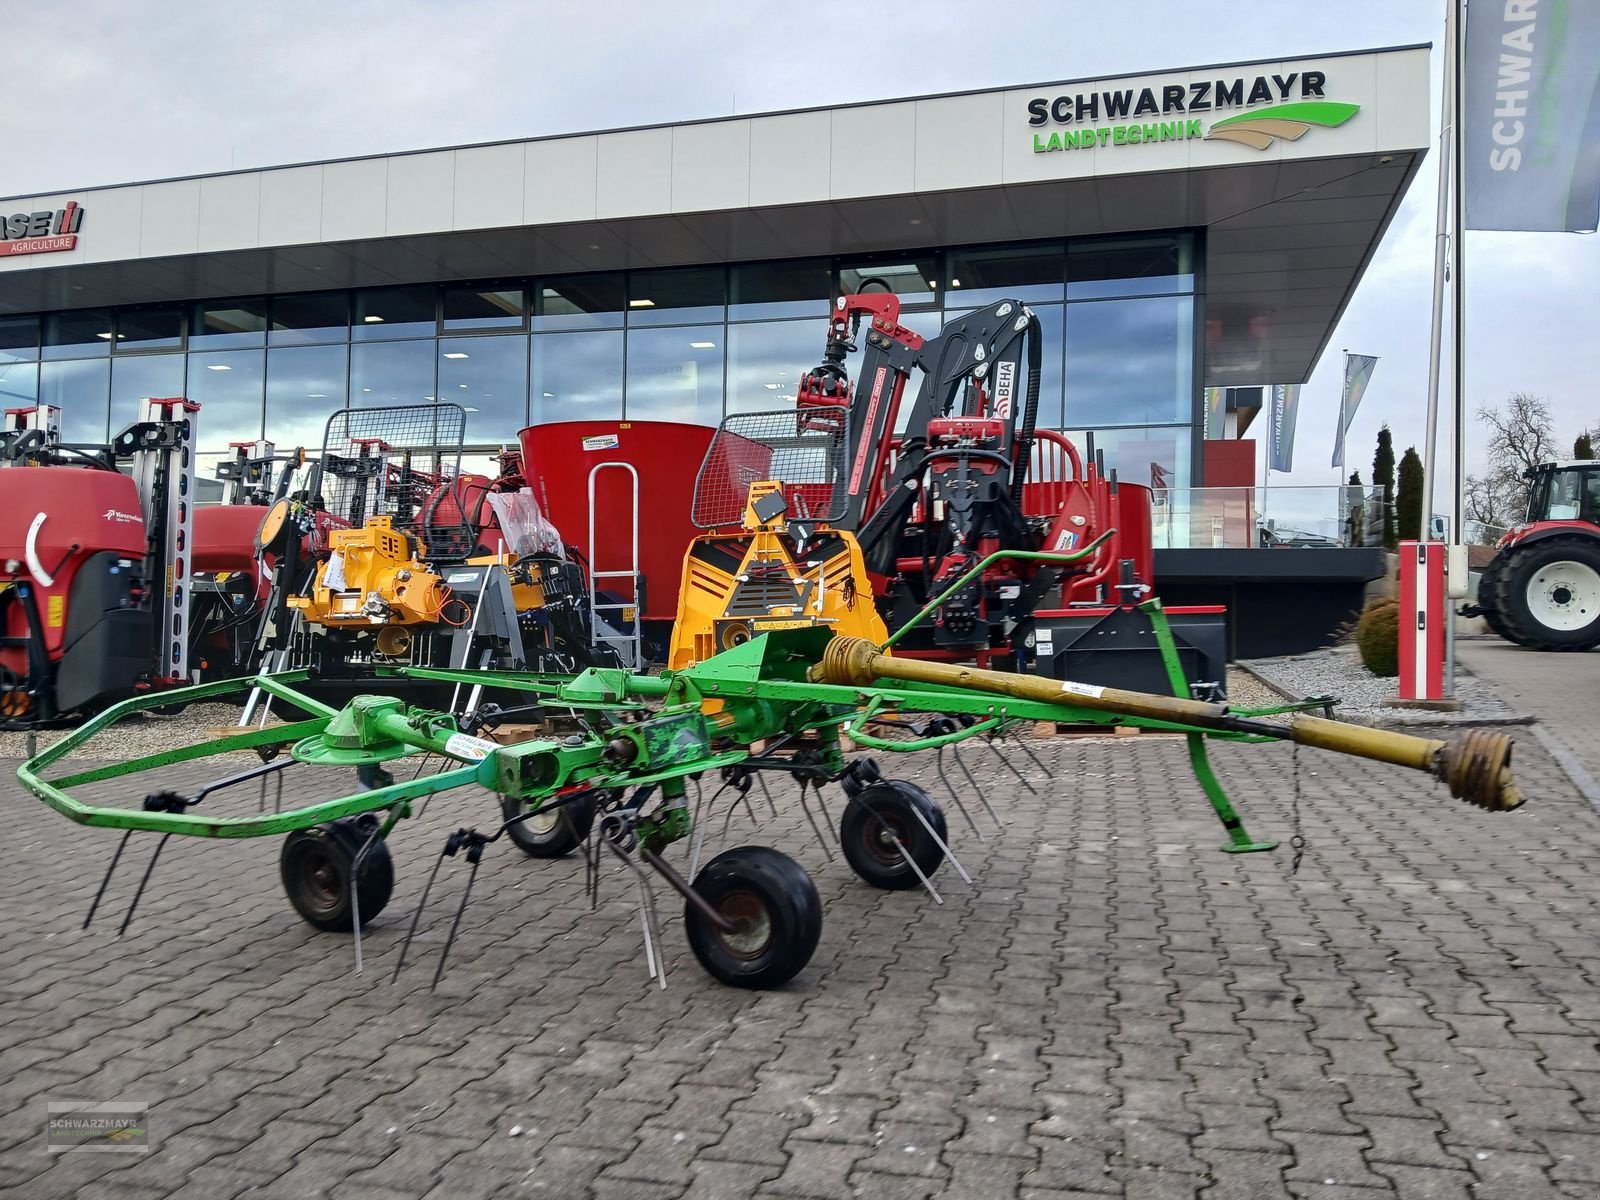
1230, 645, 1534, 725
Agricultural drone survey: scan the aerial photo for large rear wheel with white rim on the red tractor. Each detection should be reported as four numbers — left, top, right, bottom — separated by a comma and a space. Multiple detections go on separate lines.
1491, 538, 1600, 650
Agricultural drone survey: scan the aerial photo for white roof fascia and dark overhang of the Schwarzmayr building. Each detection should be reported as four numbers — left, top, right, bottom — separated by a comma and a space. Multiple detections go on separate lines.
0, 46, 1429, 386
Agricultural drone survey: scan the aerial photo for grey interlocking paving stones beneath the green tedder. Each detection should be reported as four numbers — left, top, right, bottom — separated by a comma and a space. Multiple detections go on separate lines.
0, 723, 1600, 1200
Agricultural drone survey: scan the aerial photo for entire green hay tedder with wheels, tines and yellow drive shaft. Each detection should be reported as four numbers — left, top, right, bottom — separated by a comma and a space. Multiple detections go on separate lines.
18, 546, 1522, 987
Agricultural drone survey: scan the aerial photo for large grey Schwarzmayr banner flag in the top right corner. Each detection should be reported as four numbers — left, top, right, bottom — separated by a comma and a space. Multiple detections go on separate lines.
1462, 0, 1600, 234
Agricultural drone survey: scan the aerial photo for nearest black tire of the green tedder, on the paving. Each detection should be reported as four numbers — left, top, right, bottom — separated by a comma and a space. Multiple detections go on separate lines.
683, 846, 822, 987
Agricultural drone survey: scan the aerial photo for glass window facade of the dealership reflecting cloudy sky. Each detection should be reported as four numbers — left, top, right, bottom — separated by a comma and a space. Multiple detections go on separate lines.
0, 234, 1203, 486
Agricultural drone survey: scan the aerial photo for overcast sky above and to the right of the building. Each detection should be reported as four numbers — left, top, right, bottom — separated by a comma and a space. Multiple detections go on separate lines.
0, 0, 1600, 499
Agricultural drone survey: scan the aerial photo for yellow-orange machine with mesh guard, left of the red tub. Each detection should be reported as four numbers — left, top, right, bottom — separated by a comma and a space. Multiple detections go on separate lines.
258, 405, 618, 691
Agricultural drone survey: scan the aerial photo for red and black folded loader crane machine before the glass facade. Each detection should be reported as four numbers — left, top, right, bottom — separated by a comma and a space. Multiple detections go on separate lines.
798, 293, 1152, 666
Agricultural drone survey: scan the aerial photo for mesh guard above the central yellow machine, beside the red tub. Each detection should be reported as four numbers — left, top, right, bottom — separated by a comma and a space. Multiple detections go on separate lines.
693, 405, 846, 530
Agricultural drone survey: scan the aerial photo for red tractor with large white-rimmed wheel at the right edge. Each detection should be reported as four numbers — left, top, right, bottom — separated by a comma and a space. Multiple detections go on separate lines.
1461, 461, 1600, 650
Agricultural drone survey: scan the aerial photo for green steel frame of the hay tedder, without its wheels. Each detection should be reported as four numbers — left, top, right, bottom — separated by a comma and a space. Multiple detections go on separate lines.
18, 579, 1320, 853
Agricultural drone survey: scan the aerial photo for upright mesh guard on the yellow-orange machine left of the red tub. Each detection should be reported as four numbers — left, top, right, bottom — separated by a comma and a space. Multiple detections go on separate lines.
318, 405, 475, 558
